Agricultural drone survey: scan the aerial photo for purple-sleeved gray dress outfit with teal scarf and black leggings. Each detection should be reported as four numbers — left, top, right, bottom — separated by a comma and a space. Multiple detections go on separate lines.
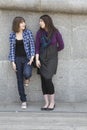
36, 30, 64, 95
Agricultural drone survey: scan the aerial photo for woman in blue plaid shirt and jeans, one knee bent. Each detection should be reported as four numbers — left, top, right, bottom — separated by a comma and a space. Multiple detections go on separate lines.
9, 17, 35, 108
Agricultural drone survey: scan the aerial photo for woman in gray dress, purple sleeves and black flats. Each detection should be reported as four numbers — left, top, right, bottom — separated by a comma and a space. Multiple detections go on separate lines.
36, 15, 64, 110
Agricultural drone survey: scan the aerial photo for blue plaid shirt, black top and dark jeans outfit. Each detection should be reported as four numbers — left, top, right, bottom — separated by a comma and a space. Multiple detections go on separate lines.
9, 29, 35, 102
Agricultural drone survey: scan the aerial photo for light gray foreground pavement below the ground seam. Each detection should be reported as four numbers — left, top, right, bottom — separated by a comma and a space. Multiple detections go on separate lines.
0, 112, 87, 130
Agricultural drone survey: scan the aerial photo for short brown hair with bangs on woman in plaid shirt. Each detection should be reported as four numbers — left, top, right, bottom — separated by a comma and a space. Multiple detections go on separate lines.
12, 16, 25, 33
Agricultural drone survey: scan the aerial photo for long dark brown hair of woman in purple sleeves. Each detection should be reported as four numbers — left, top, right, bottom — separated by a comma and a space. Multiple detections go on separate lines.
40, 15, 58, 39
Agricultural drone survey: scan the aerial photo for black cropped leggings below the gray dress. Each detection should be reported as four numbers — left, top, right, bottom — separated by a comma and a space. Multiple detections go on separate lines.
41, 76, 54, 95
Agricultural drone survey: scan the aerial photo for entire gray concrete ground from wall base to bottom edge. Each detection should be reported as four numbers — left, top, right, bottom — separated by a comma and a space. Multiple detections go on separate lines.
0, 102, 87, 130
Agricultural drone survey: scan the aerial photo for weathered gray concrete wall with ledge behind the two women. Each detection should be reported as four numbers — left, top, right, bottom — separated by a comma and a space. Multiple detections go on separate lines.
0, 0, 87, 103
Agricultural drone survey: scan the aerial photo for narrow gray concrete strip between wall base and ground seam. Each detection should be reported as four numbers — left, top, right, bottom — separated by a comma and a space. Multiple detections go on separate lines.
0, 102, 87, 113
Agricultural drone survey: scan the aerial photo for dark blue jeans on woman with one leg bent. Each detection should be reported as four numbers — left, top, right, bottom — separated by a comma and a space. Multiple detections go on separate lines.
16, 57, 32, 102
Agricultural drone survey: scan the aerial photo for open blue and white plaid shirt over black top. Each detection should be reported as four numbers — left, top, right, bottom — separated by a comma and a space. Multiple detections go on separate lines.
9, 29, 35, 62
